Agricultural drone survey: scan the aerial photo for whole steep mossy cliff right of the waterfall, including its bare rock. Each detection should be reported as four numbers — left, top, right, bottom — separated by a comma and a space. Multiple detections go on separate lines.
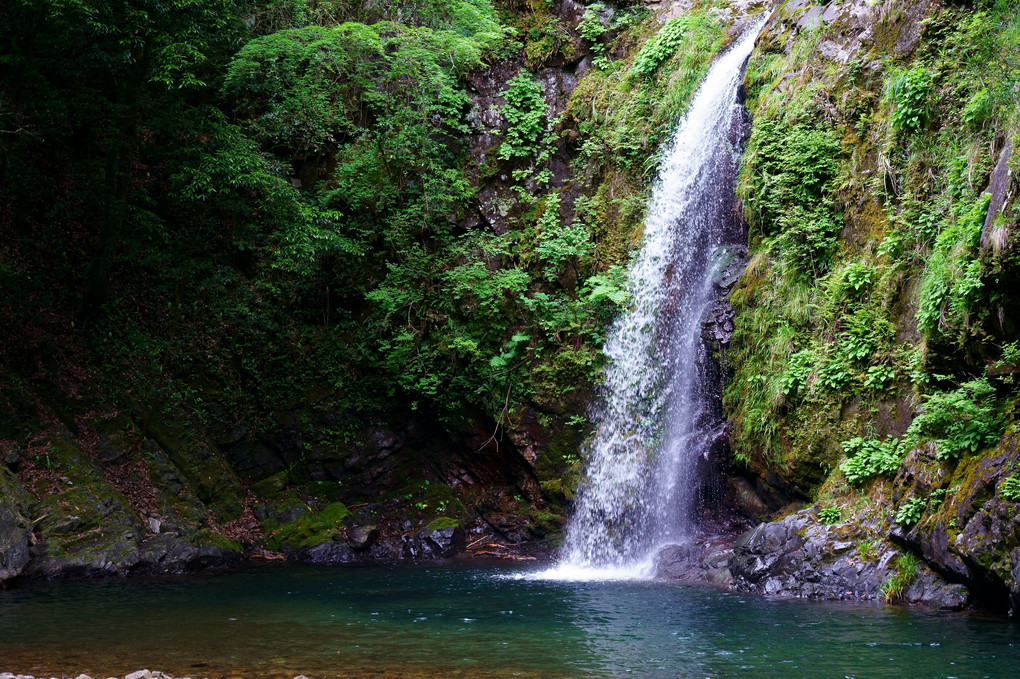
725, 0, 1020, 609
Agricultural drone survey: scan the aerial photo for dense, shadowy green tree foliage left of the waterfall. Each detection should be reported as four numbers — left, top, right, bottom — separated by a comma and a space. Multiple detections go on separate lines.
0, 0, 632, 436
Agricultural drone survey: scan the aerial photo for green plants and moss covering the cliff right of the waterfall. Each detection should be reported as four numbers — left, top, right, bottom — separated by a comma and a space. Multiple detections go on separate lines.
724, 2, 1020, 509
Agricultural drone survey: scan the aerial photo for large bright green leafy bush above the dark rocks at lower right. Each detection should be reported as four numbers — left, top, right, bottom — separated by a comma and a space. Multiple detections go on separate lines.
907, 377, 1004, 460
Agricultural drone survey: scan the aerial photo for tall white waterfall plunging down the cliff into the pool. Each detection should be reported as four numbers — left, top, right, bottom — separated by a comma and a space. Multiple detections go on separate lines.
548, 17, 765, 577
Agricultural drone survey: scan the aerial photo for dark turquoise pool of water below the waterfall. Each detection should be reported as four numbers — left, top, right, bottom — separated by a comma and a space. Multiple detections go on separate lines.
0, 564, 1020, 679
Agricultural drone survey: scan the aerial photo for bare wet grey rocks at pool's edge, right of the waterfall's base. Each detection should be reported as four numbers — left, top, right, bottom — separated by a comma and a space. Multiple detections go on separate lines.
729, 510, 970, 610
